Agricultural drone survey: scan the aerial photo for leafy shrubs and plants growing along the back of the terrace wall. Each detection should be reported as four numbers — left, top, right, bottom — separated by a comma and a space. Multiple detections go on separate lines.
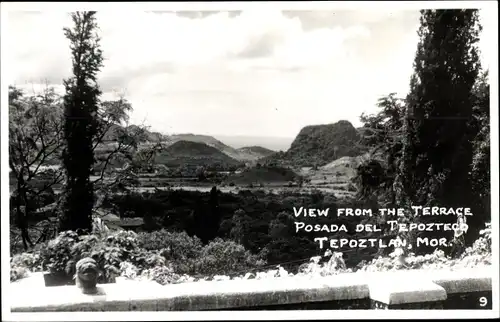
10, 223, 492, 285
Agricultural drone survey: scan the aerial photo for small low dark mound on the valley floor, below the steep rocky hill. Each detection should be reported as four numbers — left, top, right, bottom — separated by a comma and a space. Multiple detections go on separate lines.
227, 166, 300, 185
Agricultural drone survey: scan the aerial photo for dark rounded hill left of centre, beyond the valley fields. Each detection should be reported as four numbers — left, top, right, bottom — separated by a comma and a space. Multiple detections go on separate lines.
155, 141, 242, 169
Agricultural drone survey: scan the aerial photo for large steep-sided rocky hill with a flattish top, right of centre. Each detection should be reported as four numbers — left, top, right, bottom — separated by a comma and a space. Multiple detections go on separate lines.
264, 121, 366, 167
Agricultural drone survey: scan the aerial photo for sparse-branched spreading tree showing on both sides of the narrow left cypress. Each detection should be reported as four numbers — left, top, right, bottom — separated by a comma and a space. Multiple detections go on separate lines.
9, 85, 161, 249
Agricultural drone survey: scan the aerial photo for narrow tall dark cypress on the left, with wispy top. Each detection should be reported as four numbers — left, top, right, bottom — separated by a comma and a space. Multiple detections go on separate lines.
59, 11, 103, 231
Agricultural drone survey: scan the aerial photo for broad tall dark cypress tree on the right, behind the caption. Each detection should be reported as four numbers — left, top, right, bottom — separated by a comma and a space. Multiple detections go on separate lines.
399, 9, 481, 251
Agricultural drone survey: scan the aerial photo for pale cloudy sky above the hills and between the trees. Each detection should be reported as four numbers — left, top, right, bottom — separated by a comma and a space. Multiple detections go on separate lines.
2, 7, 498, 143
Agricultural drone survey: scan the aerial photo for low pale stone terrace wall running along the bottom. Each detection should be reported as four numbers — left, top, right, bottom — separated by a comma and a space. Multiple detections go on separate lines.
9, 268, 493, 312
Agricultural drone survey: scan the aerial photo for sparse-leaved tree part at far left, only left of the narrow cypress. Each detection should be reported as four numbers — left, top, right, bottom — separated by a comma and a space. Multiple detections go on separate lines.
9, 86, 63, 249
